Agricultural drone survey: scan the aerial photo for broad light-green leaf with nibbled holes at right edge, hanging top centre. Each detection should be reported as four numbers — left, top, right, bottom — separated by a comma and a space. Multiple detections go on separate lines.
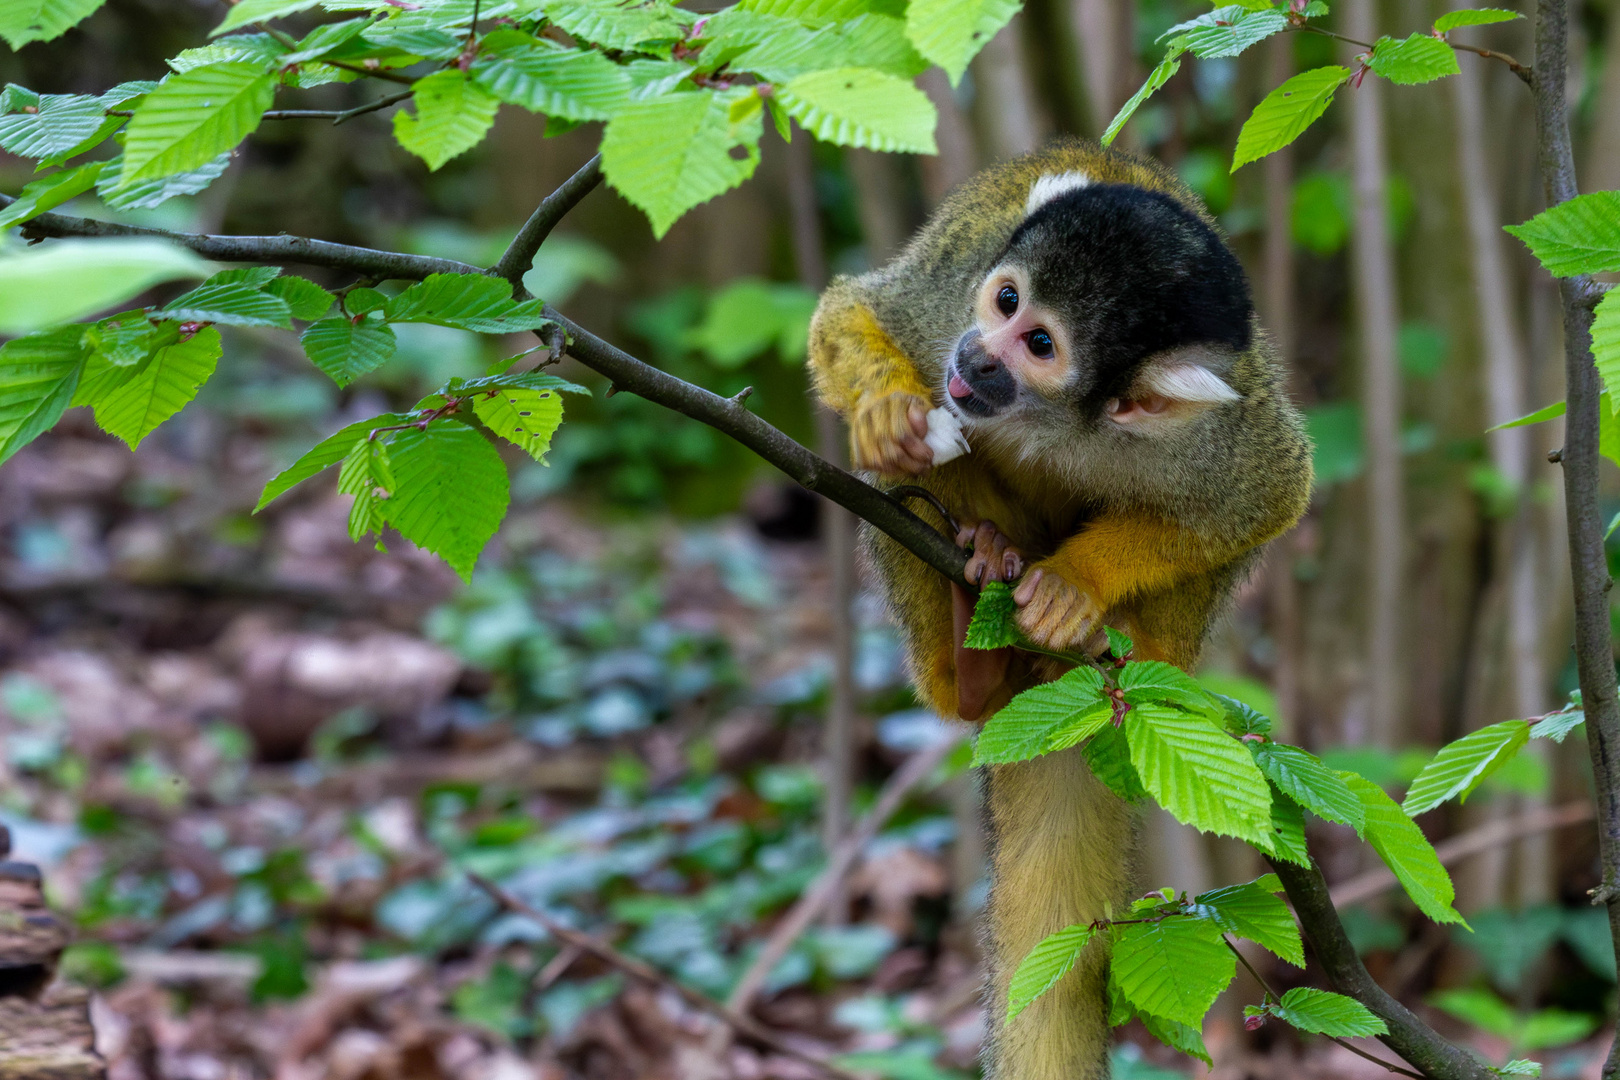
601, 87, 765, 238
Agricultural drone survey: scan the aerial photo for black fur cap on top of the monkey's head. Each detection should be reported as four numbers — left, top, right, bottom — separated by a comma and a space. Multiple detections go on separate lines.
1003, 183, 1254, 406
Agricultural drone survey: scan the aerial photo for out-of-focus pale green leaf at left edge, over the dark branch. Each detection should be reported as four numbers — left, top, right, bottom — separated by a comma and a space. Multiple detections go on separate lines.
0, 240, 211, 334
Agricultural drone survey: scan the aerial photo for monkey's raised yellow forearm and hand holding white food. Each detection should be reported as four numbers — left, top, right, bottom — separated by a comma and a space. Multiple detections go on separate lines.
810, 285, 933, 476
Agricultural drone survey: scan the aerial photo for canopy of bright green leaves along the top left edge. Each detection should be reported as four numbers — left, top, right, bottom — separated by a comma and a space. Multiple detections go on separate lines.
0, 0, 1019, 236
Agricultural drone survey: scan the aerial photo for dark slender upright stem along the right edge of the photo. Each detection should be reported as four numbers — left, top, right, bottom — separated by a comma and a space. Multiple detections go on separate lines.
1534, 0, 1620, 1080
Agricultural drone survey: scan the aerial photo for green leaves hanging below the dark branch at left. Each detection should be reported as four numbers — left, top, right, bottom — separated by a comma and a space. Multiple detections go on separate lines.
0, 255, 582, 578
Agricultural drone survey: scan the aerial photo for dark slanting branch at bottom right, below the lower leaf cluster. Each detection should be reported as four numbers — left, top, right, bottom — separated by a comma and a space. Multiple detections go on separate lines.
1265, 858, 1495, 1080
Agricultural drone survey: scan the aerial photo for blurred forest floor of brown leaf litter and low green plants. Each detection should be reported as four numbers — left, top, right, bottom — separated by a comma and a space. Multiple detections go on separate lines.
0, 419, 1599, 1080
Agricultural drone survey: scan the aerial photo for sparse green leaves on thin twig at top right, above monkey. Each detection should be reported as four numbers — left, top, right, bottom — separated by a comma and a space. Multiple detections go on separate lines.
1103, 0, 1523, 172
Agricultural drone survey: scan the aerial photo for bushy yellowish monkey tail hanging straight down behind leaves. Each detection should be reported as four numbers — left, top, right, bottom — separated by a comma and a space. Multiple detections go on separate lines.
985, 750, 1136, 1080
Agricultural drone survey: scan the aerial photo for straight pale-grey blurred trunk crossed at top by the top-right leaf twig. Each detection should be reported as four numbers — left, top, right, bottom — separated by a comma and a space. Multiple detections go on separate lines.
1345, 0, 1406, 746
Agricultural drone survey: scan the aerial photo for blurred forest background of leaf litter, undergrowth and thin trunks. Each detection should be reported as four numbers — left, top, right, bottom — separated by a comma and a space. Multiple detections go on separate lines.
0, 0, 1620, 1080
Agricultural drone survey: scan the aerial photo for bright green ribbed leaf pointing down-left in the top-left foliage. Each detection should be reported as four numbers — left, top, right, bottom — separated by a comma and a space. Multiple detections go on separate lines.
118, 63, 275, 189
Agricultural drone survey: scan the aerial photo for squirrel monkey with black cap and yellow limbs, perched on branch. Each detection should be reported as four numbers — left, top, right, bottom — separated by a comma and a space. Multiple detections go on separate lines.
810, 142, 1311, 1080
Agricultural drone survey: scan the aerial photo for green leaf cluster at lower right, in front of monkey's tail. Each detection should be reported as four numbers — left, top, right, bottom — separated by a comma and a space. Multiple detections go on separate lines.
966, 583, 1584, 1059
